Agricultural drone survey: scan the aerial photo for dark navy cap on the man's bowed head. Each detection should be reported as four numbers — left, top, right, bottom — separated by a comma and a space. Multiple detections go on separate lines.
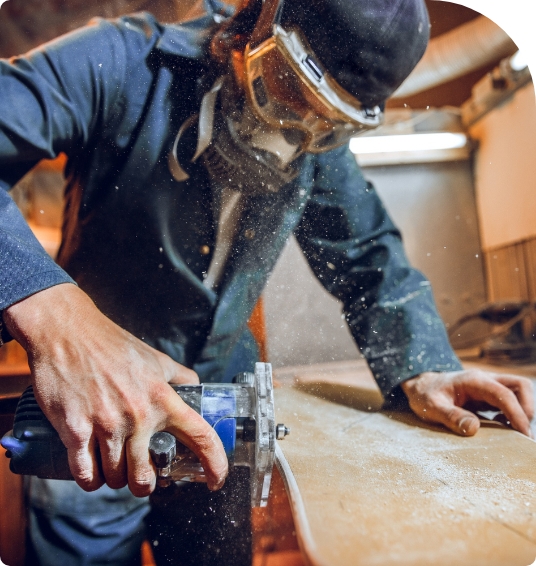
281, 0, 430, 106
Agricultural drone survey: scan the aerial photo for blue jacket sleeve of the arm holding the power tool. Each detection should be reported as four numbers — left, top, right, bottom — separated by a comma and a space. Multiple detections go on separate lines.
0, 16, 126, 312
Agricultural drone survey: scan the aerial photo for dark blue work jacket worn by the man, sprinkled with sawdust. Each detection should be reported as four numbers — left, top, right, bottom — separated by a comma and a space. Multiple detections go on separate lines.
0, 8, 460, 395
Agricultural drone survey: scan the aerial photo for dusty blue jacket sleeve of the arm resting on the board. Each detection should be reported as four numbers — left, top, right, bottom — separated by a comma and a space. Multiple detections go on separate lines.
296, 148, 461, 401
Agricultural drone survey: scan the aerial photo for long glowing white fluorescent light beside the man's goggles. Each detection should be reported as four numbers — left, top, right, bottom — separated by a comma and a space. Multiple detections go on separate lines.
350, 132, 467, 155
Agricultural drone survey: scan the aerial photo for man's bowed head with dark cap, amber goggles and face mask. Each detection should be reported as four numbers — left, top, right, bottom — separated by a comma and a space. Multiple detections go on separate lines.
191, 0, 429, 192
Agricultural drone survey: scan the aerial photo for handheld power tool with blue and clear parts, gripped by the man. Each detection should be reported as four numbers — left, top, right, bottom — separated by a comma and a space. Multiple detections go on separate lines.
0, 362, 290, 507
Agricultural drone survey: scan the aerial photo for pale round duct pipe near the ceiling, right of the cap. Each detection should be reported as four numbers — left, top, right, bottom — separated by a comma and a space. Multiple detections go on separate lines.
393, 16, 517, 98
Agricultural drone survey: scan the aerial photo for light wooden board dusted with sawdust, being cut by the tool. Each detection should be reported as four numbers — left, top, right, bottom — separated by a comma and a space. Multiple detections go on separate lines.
275, 363, 536, 566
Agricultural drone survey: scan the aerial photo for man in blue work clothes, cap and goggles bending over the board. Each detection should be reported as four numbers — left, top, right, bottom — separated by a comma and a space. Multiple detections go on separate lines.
0, 0, 533, 564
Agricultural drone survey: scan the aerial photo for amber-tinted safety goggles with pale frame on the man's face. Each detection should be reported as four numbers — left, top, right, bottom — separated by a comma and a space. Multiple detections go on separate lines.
244, 0, 383, 153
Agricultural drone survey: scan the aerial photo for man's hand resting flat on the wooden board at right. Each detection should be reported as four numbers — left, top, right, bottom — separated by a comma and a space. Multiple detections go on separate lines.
402, 369, 534, 438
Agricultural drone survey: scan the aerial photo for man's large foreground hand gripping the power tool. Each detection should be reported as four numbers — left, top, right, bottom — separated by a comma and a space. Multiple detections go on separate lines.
3, 283, 227, 497
